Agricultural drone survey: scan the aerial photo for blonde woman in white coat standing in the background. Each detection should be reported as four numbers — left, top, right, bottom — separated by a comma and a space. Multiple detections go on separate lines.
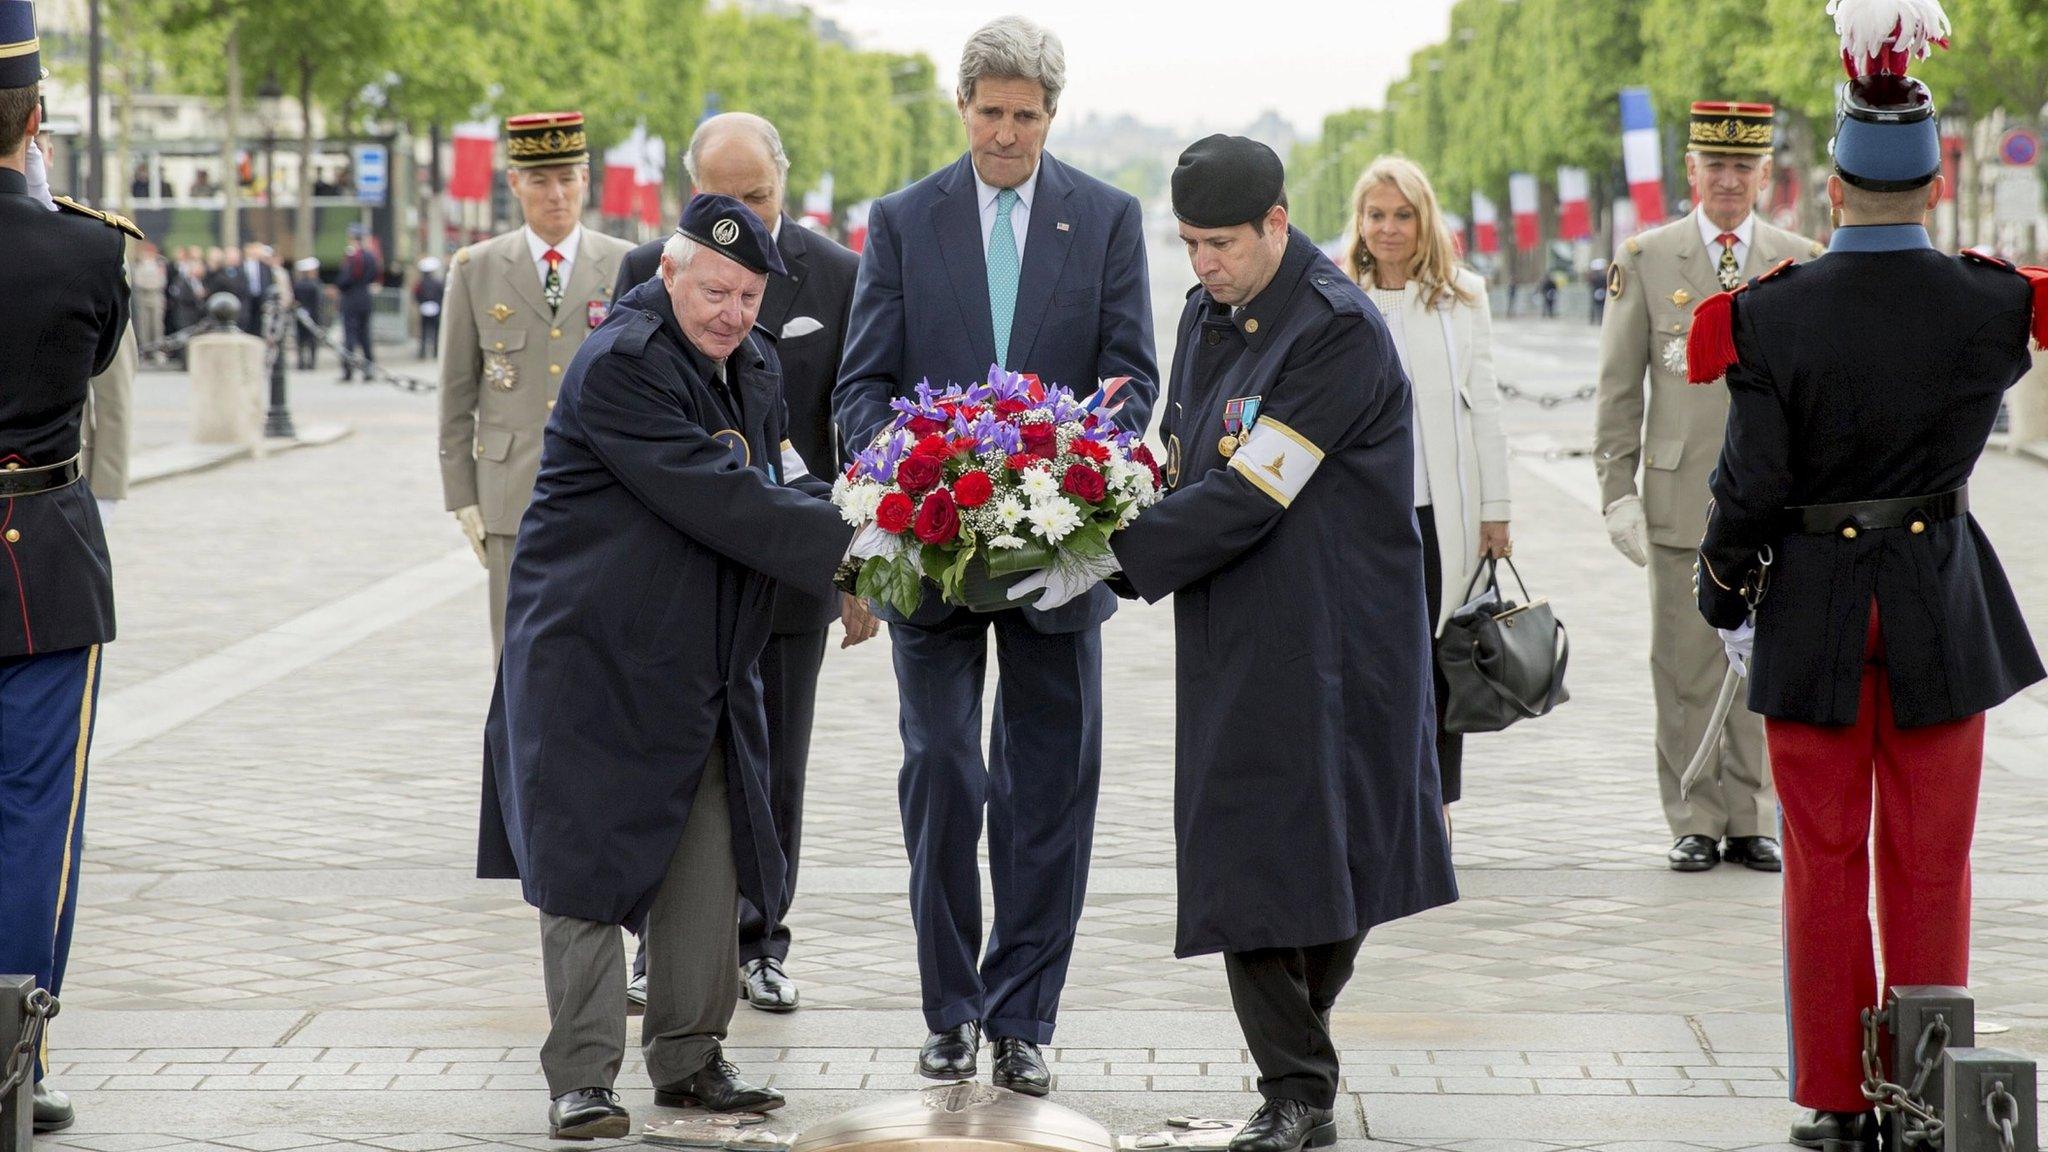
1343, 156, 1511, 816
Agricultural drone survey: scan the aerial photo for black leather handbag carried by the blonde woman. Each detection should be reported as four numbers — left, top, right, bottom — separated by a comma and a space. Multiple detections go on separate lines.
1436, 558, 1571, 734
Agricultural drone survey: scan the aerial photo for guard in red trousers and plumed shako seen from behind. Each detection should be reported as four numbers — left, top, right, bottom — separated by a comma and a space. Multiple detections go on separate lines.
1688, 2, 2048, 1152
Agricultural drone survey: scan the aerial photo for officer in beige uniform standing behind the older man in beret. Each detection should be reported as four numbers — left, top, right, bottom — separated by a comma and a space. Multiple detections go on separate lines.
440, 113, 631, 650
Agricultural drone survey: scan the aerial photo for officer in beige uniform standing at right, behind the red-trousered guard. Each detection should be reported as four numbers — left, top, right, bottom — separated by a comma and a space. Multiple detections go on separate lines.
1593, 102, 1821, 871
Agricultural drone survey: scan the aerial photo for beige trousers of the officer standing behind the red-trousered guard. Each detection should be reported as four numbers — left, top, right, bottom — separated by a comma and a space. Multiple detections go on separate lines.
1651, 543, 1778, 840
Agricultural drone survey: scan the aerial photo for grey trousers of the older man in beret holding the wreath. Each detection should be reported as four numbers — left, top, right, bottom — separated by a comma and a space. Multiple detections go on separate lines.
541, 746, 739, 1097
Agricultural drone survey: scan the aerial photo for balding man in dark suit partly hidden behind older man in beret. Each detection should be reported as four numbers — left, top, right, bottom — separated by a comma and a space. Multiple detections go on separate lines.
612, 113, 879, 1013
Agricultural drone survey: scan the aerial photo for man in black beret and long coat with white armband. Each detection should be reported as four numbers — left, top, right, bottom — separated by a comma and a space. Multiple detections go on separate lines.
1112, 135, 1458, 1152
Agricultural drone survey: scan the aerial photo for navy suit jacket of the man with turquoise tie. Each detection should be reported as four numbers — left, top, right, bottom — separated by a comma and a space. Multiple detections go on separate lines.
831, 152, 1159, 633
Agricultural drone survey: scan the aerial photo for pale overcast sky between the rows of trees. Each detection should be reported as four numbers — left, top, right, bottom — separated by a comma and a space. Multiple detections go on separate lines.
813, 0, 1452, 137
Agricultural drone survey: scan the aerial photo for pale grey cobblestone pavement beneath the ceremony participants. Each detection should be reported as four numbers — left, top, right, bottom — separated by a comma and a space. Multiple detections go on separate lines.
28, 320, 2048, 1152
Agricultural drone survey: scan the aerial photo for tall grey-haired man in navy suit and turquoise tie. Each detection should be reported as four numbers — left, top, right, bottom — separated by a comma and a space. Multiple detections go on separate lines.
831, 16, 1159, 1095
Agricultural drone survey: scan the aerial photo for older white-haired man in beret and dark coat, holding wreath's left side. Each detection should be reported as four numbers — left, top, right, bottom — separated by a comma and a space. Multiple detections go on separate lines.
477, 195, 854, 1138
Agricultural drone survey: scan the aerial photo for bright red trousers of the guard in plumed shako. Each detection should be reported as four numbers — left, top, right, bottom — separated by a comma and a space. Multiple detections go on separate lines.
1763, 607, 1985, 1111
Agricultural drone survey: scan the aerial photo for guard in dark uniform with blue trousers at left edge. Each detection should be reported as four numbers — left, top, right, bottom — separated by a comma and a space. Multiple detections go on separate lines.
0, 0, 141, 1132
